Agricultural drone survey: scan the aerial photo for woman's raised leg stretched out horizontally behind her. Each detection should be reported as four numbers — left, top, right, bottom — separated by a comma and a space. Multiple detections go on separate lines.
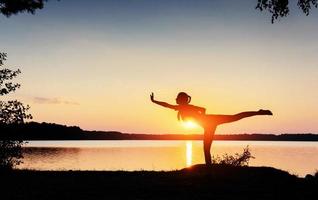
211, 110, 273, 124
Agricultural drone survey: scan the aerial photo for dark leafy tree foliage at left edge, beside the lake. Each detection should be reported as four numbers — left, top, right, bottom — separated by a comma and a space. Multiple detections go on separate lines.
0, 53, 32, 169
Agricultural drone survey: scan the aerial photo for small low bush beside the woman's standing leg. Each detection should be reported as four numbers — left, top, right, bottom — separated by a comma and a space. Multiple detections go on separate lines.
212, 146, 255, 167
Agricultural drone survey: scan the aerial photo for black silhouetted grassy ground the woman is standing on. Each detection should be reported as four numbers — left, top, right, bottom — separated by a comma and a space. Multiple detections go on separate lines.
0, 165, 318, 200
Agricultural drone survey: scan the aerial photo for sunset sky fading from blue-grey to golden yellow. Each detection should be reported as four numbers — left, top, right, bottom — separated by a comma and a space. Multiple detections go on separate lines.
0, 0, 318, 134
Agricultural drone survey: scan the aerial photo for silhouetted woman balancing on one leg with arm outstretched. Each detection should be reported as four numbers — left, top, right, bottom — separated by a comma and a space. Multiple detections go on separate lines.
150, 92, 273, 165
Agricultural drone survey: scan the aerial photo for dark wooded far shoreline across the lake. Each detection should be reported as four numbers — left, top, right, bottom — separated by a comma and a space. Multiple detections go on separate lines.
0, 122, 318, 141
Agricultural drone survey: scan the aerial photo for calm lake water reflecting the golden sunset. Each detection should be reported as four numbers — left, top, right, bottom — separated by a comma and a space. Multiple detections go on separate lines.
18, 140, 318, 176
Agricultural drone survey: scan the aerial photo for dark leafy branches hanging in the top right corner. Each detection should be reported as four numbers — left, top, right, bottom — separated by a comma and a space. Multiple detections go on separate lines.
256, 0, 318, 23
